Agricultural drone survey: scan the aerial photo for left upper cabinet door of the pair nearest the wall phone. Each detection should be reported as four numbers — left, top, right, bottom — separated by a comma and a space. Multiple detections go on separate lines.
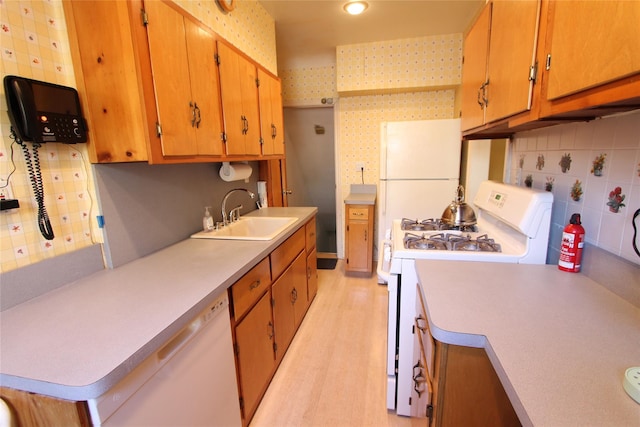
144, 1, 198, 156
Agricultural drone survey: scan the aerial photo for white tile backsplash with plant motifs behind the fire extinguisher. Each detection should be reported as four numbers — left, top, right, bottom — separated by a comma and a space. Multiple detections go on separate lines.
511, 111, 640, 264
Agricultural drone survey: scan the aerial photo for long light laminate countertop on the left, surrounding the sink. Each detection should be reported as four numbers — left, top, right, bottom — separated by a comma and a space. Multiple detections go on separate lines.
0, 207, 317, 401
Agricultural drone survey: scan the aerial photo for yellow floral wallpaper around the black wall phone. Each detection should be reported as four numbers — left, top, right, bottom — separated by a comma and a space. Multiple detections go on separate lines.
0, 0, 102, 271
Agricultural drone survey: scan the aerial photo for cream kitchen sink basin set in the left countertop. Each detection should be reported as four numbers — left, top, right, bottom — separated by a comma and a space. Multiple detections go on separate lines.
191, 216, 298, 240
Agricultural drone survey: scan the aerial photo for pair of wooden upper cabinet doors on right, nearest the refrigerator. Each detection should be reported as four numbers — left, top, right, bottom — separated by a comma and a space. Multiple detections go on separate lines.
462, 0, 540, 130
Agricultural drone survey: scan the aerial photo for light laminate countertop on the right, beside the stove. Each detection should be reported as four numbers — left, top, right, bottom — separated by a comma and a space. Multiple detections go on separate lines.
416, 260, 640, 426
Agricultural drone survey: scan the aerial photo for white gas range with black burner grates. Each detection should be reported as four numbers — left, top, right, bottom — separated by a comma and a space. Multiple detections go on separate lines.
378, 181, 553, 416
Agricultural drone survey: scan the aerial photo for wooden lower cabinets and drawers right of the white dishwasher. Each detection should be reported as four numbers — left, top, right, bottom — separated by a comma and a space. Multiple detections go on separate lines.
229, 217, 318, 426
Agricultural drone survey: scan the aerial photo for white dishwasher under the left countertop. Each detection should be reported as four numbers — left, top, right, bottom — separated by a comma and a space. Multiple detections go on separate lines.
88, 293, 242, 427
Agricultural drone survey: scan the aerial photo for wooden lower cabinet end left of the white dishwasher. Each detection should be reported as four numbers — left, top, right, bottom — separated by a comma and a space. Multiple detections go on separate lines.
0, 387, 91, 427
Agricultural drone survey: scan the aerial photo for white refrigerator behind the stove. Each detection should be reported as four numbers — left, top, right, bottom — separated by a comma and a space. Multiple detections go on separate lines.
378, 119, 462, 250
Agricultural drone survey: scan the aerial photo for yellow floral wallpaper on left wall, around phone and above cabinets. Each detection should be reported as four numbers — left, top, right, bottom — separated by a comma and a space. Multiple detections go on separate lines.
0, 0, 277, 272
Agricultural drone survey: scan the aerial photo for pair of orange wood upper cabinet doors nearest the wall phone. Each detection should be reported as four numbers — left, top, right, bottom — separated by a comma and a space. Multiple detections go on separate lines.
145, 1, 223, 156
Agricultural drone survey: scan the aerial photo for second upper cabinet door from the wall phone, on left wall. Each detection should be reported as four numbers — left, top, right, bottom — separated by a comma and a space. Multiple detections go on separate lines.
185, 19, 224, 156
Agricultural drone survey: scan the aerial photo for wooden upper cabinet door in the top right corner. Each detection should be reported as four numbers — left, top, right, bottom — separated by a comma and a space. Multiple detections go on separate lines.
547, 0, 640, 99
